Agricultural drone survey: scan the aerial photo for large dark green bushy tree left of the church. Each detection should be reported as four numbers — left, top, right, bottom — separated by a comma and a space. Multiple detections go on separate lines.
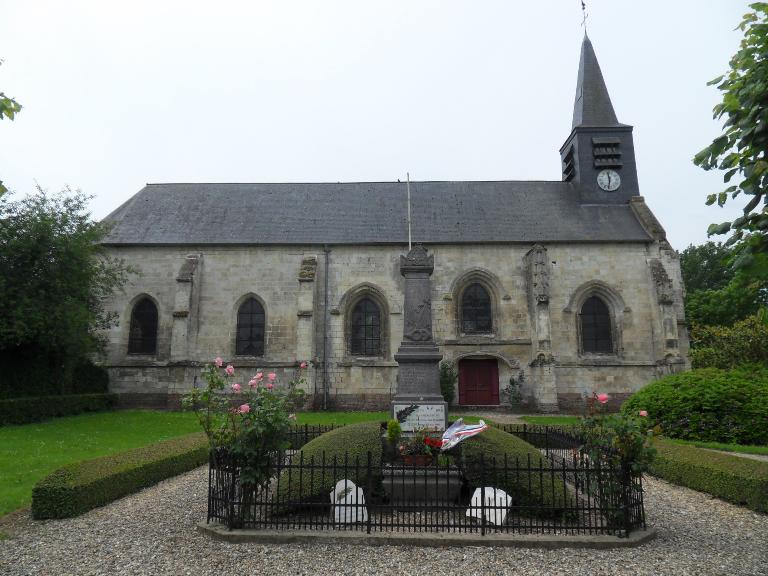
0, 189, 131, 395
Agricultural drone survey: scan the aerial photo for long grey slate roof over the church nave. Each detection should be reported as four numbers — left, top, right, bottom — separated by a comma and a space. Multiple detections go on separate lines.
105, 181, 650, 245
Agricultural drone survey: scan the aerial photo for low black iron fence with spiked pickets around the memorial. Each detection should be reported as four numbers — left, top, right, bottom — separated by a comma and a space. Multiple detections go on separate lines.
208, 426, 645, 536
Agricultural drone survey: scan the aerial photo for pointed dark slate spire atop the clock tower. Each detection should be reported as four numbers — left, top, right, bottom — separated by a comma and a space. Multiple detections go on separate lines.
573, 33, 621, 128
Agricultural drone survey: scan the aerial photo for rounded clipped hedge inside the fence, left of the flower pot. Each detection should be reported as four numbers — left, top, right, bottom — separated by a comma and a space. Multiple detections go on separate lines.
280, 421, 382, 500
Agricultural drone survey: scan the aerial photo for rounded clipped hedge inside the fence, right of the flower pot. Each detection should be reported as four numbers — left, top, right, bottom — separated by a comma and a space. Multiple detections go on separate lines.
456, 427, 567, 516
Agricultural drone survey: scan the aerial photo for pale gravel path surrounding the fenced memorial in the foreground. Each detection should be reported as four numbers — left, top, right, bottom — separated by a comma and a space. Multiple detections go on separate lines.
0, 468, 768, 576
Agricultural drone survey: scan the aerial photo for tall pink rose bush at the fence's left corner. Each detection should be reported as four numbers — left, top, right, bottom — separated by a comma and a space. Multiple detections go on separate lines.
182, 358, 306, 486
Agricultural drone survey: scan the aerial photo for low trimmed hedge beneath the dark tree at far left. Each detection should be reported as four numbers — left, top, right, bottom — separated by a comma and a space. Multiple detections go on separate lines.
0, 394, 117, 426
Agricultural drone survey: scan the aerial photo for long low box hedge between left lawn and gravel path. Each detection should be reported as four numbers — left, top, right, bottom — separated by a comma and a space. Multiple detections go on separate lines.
32, 432, 208, 519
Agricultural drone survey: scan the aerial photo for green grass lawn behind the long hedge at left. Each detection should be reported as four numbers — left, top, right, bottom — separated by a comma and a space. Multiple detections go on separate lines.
0, 411, 200, 516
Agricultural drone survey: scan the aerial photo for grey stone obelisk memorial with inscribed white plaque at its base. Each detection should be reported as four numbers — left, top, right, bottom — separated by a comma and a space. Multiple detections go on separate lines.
392, 244, 448, 432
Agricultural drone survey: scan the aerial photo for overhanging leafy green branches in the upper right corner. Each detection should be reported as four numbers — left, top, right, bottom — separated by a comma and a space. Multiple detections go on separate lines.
693, 2, 768, 268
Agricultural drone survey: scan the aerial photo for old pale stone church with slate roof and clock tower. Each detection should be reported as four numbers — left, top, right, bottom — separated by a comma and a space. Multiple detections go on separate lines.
99, 37, 688, 412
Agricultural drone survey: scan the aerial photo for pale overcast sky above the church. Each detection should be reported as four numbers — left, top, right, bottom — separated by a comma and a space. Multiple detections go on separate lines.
0, 0, 747, 249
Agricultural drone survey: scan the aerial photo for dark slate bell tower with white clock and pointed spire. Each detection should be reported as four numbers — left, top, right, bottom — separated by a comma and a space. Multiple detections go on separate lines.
560, 34, 640, 204
